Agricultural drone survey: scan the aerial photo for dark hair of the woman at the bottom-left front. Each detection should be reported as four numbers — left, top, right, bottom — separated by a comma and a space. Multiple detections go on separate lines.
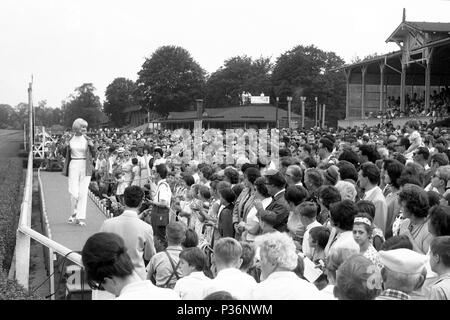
81, 232, 134, 284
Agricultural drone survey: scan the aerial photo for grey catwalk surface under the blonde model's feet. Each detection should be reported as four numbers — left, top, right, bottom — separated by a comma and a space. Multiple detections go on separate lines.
41, 171, 106, 251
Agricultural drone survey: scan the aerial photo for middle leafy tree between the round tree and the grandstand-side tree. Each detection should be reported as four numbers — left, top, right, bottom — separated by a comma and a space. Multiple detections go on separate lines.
206, 56, 272, 108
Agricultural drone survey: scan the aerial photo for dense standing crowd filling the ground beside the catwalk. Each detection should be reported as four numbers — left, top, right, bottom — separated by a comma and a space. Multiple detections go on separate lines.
61, 120, 450, 300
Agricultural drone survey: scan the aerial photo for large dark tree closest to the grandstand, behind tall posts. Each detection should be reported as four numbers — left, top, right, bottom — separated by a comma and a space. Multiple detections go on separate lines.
272, 45, 346, 126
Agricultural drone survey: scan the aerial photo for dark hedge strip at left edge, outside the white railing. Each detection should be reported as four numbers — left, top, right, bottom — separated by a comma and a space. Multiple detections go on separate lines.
0, 158, 23, 272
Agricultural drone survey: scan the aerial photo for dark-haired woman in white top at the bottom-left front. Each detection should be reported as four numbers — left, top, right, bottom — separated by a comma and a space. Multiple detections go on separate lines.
81, 232, 179, 300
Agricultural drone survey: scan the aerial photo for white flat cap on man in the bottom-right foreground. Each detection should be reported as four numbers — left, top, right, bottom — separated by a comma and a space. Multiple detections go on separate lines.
378, 248, 428, 274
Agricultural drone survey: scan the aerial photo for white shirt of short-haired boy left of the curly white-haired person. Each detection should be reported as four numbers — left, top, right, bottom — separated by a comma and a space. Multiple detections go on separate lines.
203, 268, 256, 300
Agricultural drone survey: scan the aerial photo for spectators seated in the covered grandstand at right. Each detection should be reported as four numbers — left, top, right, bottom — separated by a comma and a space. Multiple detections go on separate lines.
368, 86, 450, 119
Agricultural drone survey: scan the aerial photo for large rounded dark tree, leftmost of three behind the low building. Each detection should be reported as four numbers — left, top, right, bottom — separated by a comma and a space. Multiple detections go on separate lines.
137, 46, 206, 114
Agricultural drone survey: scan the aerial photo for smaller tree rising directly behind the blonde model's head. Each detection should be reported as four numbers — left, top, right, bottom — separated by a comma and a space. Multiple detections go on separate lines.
62, 83, 103, 127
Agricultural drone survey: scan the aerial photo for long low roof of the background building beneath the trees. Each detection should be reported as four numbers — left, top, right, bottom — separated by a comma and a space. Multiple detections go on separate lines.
163, 105, 300, 122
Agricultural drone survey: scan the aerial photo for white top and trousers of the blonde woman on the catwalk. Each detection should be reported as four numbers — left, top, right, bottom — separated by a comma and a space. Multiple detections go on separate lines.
69, 136, 91, 220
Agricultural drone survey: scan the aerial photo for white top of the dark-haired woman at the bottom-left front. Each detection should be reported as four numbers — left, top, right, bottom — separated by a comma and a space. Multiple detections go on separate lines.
116, 280, 180, 300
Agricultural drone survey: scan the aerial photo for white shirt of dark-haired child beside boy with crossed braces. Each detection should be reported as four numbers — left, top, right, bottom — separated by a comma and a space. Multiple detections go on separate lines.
173, 271, 212, 300
